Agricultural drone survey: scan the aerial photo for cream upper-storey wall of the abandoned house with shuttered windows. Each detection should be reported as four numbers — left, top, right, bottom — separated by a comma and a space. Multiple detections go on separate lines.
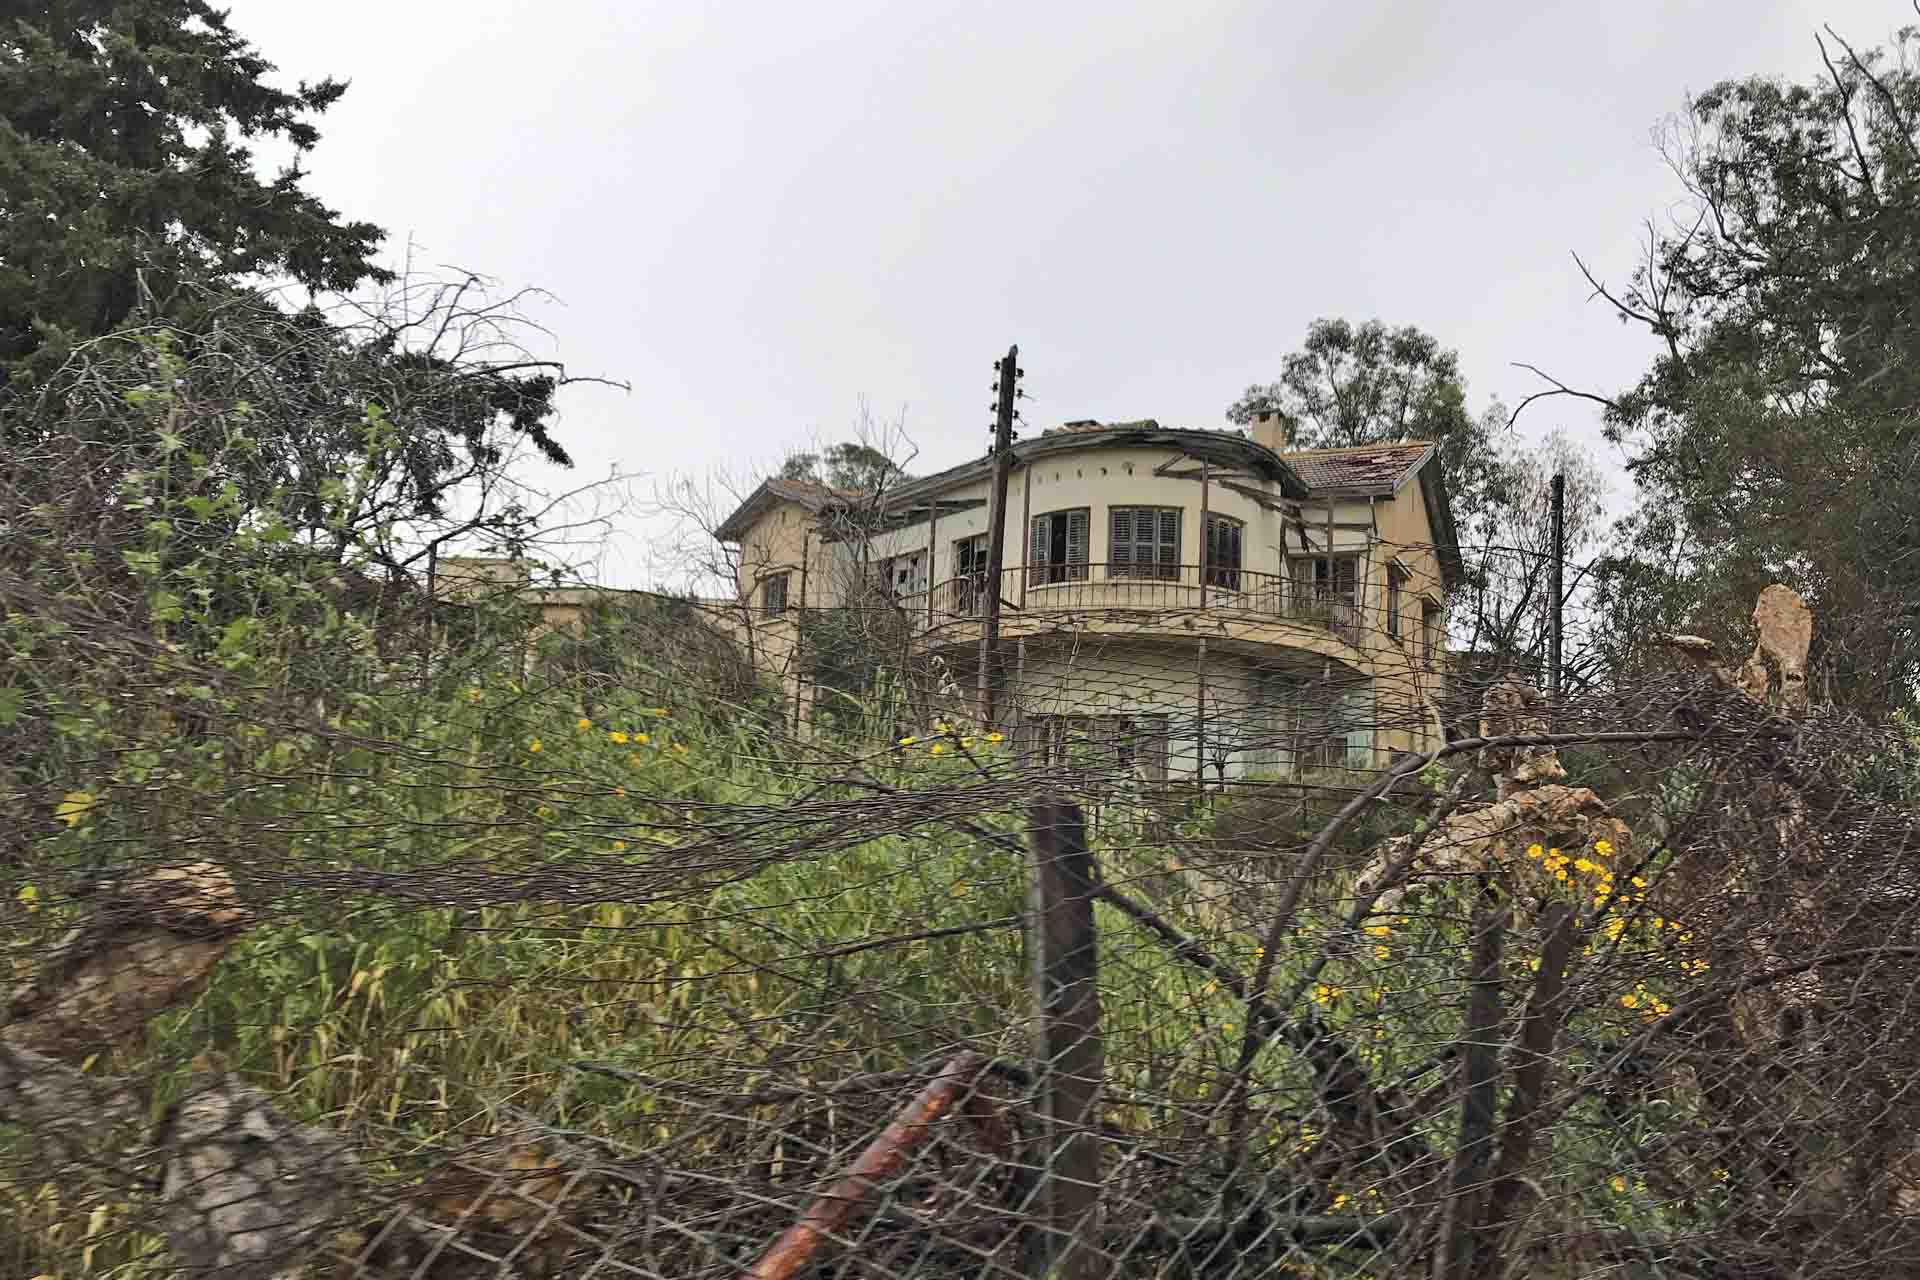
739, 447, 1446, 660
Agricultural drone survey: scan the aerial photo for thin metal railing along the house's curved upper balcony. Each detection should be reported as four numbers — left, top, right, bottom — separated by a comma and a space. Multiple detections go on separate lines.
899, 564, 1359, 645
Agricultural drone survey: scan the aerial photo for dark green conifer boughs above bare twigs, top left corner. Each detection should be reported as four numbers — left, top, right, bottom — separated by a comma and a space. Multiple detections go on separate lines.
0, 0, 390, 372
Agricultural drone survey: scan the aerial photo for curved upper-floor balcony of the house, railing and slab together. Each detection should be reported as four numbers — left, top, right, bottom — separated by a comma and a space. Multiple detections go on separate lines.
897, 562, 1363, 660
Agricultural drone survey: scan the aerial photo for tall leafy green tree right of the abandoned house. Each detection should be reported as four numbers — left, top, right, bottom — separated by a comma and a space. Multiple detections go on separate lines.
1603, 22, 1920, 708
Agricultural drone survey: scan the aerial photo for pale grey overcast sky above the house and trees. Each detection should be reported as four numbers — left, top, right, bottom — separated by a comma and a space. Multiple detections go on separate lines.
230, 0, 1912, 585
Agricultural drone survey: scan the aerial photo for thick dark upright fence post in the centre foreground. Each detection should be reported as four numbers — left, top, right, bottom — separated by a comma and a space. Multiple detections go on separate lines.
1027, 796, 1106, 1280
